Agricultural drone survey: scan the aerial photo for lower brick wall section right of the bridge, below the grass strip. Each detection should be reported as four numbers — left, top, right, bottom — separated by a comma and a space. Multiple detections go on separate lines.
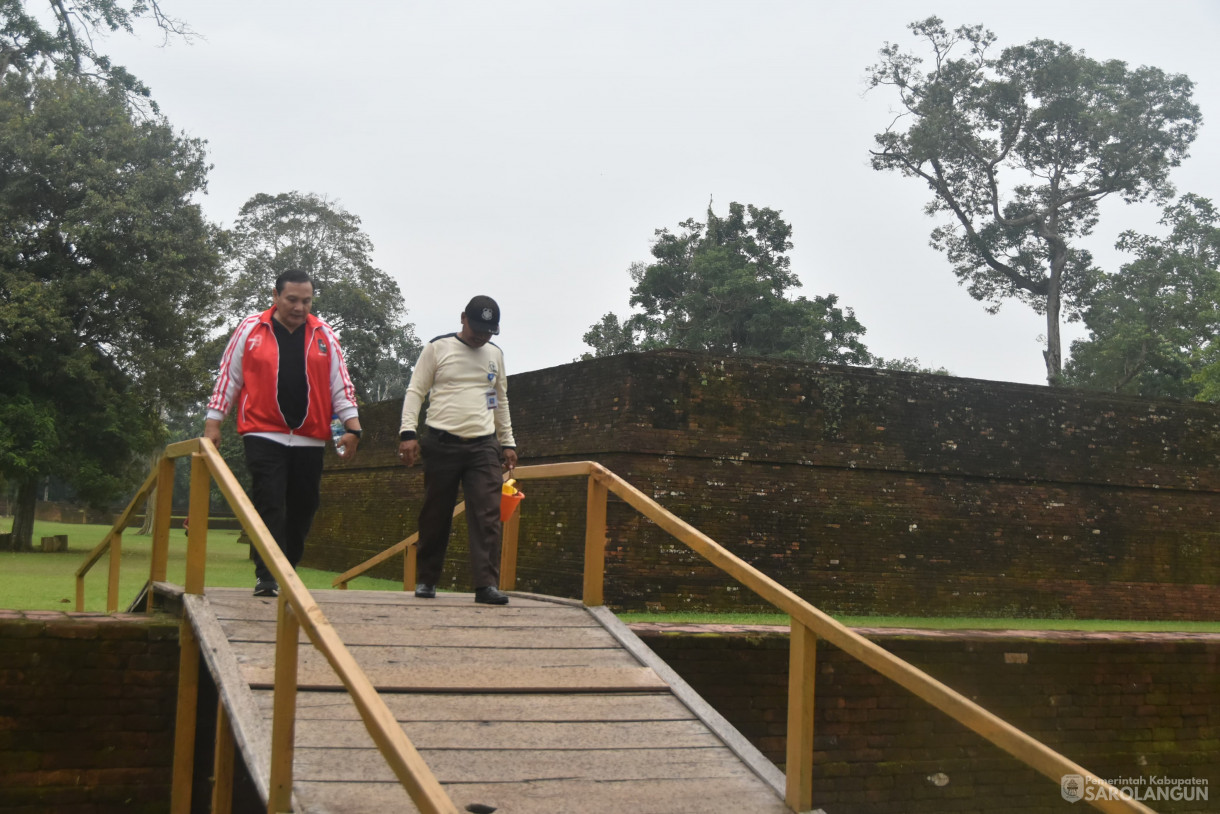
632, 625, 1220, 814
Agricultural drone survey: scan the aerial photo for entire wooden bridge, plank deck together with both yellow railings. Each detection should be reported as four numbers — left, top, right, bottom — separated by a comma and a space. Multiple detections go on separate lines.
77, 438, 1152, 814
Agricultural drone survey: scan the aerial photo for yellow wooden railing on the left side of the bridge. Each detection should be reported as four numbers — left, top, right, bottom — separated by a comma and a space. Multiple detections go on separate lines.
77, 438, 458, 814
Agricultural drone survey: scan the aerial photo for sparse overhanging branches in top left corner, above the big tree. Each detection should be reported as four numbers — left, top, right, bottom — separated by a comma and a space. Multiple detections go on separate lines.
0, 0, 193, 104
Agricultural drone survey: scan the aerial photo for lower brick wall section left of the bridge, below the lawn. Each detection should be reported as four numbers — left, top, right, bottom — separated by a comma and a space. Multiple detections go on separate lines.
0, 610, 178, 814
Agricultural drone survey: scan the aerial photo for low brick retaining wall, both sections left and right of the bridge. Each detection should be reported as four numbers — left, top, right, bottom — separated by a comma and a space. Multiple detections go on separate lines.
0, 611, 1220, 814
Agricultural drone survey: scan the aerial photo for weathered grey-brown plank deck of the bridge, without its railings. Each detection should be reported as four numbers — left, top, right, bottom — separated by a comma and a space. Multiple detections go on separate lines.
187, 588, 791, 814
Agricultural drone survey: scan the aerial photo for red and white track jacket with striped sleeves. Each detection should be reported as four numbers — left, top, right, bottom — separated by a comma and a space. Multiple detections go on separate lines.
207, 308, 359, 443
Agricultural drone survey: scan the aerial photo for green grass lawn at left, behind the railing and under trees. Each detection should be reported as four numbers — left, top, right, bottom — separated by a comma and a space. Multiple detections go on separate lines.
0, 517, 403, 610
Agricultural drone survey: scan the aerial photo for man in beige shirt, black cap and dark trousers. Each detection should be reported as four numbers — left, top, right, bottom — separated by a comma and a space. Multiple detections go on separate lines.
398, 297, 517, 605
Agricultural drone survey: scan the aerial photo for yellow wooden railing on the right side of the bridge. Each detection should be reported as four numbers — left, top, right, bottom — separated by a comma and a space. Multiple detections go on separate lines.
334, 461, 1154, 814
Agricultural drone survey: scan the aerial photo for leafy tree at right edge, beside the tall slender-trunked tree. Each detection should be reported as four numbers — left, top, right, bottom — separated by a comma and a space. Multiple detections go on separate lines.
1065, 195, 1220, 398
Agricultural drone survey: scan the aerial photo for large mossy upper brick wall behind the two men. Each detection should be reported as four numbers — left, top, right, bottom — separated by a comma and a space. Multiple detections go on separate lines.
305, 351, 1220, 619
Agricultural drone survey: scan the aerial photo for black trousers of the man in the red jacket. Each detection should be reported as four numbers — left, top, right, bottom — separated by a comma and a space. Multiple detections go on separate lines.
243, 436, 326, 580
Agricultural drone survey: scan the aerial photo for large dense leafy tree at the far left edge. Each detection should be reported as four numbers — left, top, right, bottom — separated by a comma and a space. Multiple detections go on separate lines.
0, 74, 222, 547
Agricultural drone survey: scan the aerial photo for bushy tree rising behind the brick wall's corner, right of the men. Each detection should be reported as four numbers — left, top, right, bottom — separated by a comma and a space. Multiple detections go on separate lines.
583, 203, 870, 364
